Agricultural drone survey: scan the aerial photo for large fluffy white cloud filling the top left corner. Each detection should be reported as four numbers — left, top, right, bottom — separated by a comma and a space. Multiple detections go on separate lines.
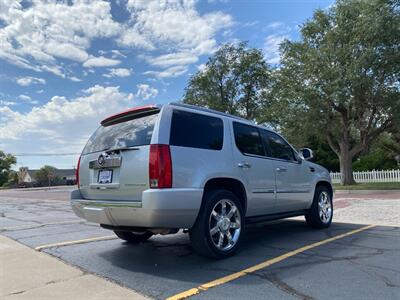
0, 0, 121, 78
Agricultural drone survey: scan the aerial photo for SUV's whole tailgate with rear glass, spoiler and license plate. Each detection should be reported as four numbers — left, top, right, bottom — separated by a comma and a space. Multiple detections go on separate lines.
79, 108, 159, 201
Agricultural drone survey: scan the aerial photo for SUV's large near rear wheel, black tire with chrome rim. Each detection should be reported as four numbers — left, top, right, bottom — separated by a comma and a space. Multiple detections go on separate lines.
189, 190, 244, 258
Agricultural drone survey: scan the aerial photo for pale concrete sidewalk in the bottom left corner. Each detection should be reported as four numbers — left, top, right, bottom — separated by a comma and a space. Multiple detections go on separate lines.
0, 235, 148, 300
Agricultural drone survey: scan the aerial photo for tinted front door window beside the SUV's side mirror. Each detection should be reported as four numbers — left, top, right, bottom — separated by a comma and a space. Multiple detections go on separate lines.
261, 130, 297, 161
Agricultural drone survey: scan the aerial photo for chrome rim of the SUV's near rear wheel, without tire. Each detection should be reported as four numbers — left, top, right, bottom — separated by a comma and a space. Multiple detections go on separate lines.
209, 199, 241, 251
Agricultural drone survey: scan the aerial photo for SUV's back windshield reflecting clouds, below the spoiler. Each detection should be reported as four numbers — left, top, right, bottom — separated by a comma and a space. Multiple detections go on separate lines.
83, 113, 158, 154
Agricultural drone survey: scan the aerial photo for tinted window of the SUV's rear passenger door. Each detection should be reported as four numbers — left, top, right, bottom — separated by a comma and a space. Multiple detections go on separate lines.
233, 122, 265, 156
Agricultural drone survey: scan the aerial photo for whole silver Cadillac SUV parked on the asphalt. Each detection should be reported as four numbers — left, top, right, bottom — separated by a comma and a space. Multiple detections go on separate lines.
71, 103, 333, 258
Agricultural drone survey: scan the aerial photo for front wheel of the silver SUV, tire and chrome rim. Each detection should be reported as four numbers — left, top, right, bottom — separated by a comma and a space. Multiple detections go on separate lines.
305, 186, 333, 229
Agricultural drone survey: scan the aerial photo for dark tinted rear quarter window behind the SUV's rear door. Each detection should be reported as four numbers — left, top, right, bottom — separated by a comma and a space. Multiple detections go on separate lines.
170, 110, 224, 150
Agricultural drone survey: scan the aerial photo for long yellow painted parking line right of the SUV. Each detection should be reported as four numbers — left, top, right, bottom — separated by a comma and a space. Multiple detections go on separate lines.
167, 225, 376, 300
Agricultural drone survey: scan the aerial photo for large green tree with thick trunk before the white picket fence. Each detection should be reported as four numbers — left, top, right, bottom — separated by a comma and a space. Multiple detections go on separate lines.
268, 0, 400, 185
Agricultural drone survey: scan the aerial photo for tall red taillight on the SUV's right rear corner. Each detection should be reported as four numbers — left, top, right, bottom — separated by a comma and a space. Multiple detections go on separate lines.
149, 145, 172, 189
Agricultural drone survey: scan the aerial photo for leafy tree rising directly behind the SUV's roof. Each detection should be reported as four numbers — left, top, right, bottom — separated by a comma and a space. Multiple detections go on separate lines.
183, 42, 270, 120
